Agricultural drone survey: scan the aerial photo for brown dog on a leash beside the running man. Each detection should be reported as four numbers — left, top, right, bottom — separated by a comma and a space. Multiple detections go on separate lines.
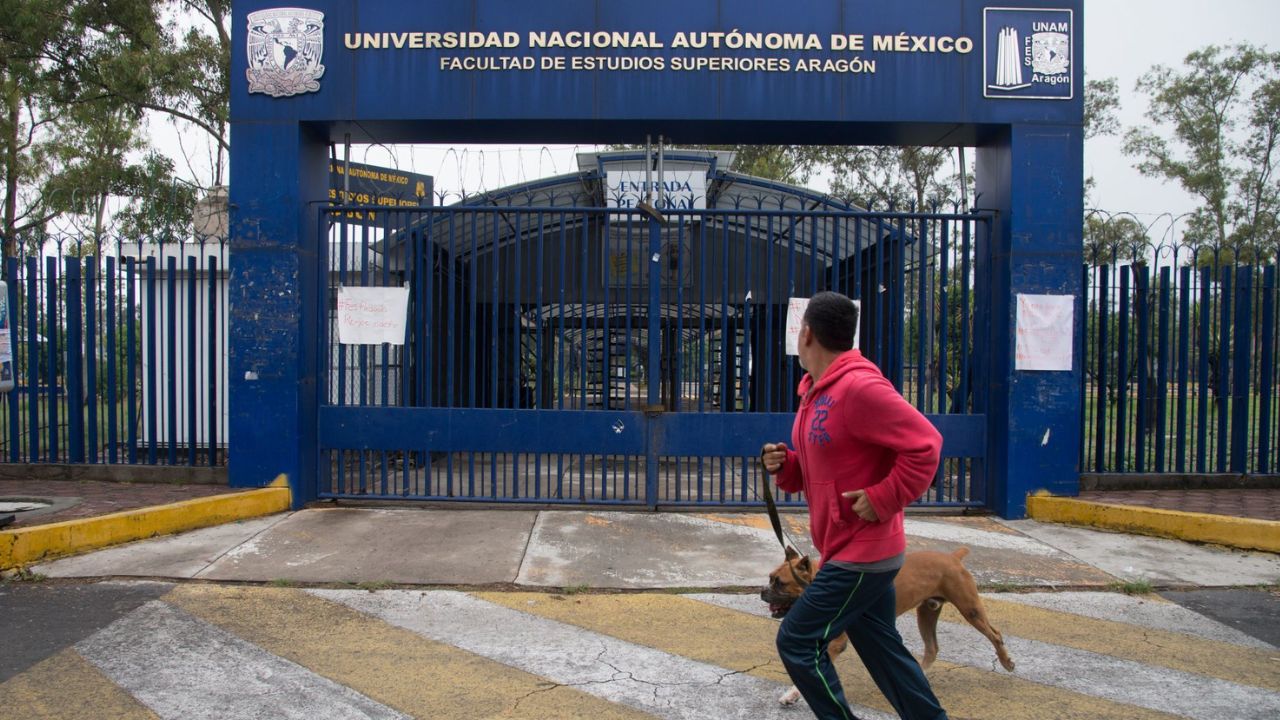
760, 547, 1014, 705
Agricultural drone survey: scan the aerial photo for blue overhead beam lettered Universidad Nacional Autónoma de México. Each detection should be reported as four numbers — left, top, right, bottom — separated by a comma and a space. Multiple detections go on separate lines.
233, 0, 1083, 136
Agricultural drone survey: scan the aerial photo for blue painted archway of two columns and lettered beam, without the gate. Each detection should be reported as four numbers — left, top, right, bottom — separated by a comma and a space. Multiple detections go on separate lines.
229, 0, 1084, 516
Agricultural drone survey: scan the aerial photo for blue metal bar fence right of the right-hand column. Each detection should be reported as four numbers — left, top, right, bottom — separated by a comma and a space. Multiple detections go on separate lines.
1080, 252, 1280, 474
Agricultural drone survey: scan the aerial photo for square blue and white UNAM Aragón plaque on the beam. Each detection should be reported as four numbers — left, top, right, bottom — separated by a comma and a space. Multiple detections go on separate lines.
983, 8, 1075, 100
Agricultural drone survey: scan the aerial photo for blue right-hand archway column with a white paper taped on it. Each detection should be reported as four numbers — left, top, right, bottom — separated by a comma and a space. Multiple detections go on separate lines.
977, 126, 1084, 518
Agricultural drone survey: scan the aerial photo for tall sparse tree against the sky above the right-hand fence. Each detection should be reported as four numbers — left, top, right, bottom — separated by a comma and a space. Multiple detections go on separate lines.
1124, 45, 1280, 261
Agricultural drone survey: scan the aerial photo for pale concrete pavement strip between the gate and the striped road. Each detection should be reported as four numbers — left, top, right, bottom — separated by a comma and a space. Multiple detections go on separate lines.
24, 507, 1280, 591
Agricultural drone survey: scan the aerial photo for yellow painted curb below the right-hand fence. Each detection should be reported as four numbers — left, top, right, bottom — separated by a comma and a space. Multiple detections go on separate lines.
1027, 495, 1280, 552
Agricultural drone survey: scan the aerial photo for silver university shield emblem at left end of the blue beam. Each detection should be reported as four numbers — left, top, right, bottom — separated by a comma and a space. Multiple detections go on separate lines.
246, 8, 324, 97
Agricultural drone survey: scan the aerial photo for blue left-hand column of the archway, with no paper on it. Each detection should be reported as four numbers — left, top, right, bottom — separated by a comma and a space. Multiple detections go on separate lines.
228, 122, 328, 507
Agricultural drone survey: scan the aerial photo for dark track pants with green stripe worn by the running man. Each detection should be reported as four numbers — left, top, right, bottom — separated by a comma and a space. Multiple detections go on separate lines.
778, 565, 947, 720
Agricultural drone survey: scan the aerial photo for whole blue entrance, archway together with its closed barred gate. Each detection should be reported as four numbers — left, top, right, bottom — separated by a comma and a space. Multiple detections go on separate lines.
229, 0, 1083, 516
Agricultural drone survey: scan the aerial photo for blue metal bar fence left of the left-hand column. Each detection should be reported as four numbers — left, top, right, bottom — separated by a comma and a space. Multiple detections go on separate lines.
0, 237, 227, 466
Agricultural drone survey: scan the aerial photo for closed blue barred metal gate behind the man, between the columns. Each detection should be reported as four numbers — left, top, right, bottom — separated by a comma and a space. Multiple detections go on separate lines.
317, 204, 991, 507
